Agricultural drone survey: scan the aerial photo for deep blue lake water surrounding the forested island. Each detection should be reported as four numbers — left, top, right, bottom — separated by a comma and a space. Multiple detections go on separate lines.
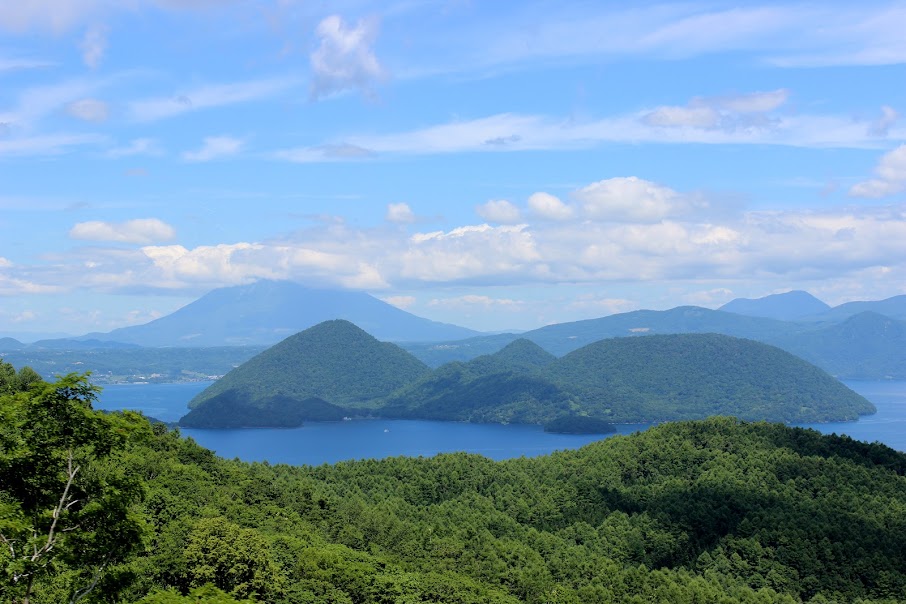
96, 381, 906, 465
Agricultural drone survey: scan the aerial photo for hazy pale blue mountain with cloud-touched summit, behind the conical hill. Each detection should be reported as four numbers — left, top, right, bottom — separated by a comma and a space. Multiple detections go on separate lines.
84, 281, 479, 347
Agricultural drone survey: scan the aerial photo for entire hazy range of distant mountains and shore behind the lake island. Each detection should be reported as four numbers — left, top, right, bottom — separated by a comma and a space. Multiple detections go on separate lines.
0, 281, 906, 379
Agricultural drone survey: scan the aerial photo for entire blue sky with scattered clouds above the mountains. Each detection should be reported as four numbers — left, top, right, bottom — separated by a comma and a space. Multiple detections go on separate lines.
0, 0, 906, 338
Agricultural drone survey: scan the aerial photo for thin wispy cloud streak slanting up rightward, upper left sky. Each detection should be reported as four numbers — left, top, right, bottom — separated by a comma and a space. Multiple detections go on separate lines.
129, 78, 297, 122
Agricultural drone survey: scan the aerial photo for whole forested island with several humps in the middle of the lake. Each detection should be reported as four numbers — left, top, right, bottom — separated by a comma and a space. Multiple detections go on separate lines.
180, 320, 874, 428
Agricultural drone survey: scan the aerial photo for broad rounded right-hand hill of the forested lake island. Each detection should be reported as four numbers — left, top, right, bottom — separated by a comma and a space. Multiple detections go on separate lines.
547, 334, 875, 422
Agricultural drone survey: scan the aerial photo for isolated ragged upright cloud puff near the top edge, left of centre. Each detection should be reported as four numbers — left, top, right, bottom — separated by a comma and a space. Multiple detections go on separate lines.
311, 15, 384, 99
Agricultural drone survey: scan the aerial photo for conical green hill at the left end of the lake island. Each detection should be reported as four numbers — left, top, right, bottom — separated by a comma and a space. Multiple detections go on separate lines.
180, 320, 428, 427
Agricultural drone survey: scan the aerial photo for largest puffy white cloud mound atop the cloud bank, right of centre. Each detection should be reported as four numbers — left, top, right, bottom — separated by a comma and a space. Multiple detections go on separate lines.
573, 176, 687, 222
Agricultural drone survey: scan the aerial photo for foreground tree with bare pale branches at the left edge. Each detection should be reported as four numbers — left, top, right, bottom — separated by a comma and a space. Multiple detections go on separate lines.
0, 372, 148, 604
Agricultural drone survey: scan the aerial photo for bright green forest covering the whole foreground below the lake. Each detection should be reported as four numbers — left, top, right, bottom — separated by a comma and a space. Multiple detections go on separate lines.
0, 364, 906, 604
